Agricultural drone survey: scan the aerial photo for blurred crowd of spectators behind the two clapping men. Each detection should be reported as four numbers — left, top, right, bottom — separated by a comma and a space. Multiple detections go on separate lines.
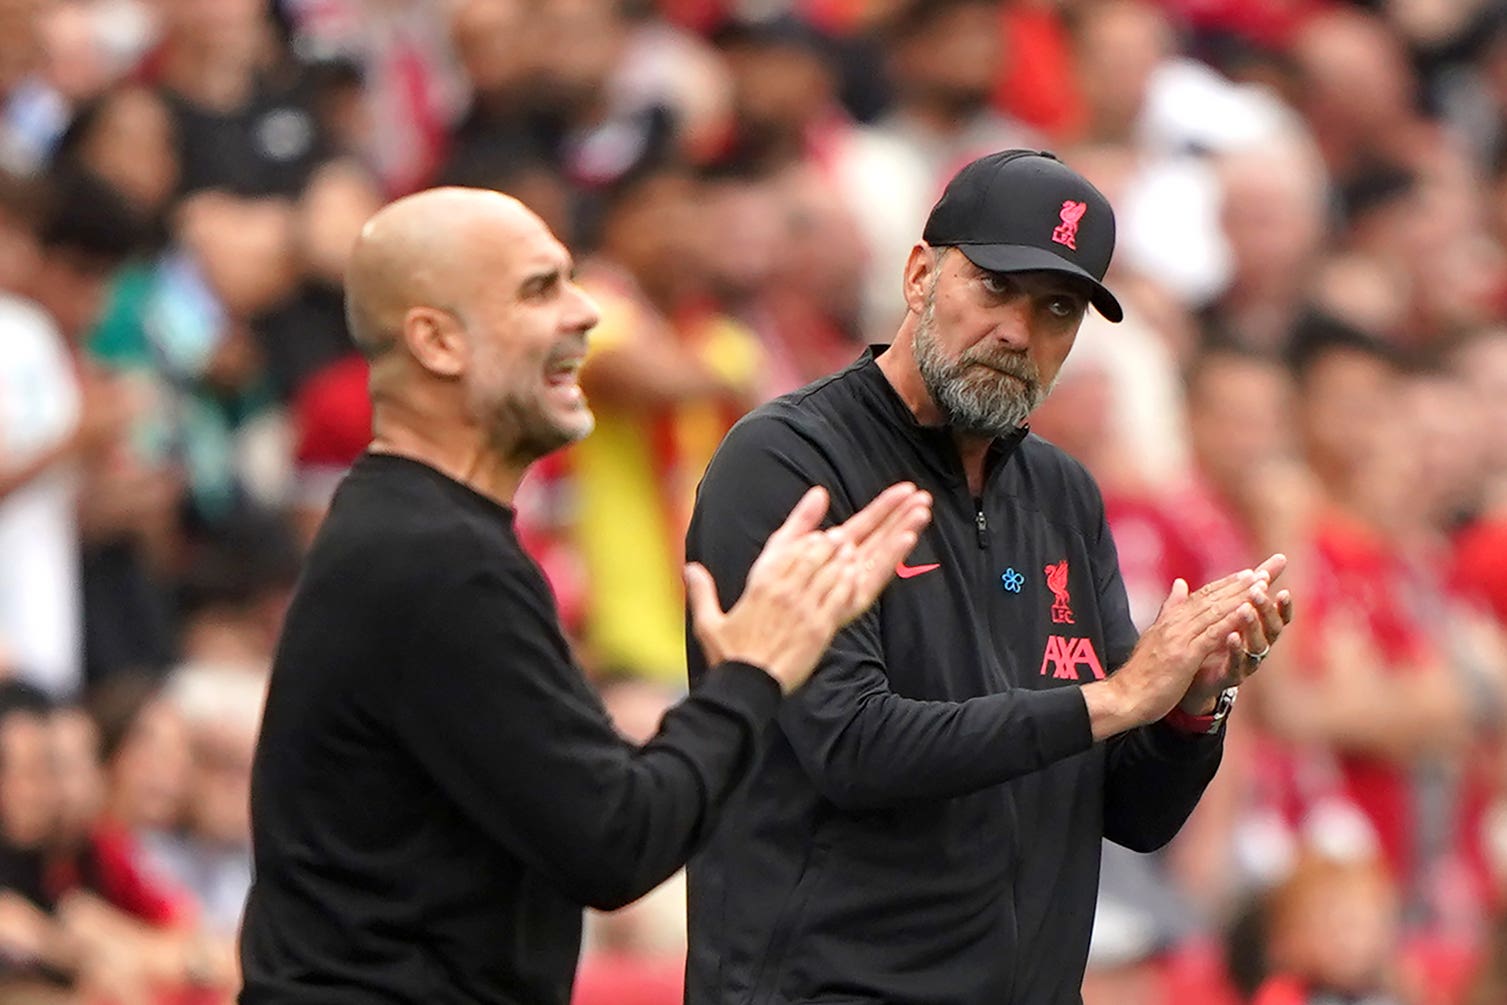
0, 0, 1507, 1005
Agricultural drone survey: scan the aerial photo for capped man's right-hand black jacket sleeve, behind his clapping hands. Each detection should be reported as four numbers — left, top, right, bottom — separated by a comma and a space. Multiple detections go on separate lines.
1094, 490, 1224, 851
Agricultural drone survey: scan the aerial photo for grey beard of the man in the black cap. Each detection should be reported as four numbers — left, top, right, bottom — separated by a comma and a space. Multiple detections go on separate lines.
915, 291, 1052, 437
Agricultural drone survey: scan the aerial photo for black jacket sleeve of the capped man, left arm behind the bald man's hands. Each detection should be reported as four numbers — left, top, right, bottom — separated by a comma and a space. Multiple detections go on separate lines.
687, 414, 1093, 811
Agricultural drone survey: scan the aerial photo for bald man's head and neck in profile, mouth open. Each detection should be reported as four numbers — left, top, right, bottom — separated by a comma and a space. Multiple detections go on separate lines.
345, 188, 600, 476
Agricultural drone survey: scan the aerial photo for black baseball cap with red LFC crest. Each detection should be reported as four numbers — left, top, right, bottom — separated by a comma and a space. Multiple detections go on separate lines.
921, 151, 1124, 321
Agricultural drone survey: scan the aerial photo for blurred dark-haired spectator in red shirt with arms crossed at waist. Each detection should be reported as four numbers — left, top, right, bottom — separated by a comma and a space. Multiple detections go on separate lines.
1263, 318, 1501, 921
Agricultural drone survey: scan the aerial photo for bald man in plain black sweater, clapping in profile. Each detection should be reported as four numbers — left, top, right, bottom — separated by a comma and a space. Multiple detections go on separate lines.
241, 188, 930, 1005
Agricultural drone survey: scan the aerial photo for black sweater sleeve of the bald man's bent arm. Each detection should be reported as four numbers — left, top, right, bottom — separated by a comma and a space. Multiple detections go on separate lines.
392, 559, 781, 909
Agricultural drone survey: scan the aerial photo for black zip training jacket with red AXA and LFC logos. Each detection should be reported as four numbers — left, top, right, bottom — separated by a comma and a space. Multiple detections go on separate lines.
687, 348, 1222, 1005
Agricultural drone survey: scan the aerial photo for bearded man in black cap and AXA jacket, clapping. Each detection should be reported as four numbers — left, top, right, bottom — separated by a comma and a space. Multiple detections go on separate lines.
687, 151, 1291, 1005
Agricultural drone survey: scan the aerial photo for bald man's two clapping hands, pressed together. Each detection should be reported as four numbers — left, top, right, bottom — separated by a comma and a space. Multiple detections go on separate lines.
686, 482, 931, 695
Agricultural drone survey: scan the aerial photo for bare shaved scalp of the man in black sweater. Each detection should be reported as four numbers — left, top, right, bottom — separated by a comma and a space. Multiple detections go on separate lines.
345, 188, 549, 360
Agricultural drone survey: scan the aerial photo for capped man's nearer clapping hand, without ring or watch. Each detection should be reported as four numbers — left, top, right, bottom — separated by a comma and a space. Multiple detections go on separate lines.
1084, 570, 1267, 740
